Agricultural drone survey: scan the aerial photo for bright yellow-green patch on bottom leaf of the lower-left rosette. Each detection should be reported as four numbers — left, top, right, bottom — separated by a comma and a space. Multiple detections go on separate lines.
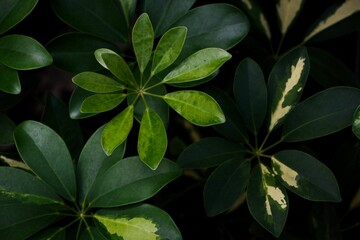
95, 215, 159, 240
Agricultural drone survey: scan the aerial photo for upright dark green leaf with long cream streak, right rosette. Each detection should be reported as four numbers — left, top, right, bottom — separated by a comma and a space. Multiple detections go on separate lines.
268, 47, 310, 132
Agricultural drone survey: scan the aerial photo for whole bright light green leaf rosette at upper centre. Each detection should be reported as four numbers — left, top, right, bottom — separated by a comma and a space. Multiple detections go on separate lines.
73, 13, 231, 169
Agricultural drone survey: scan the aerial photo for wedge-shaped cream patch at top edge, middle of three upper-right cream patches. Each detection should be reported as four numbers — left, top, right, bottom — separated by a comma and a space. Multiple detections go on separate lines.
276, 0, 302, 34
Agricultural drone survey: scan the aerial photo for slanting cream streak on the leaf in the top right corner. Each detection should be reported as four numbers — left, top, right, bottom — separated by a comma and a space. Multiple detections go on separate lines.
304, 0, 360, 42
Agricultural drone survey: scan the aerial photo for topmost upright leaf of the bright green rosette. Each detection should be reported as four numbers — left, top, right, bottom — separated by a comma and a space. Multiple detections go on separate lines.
132, 13, 154, 74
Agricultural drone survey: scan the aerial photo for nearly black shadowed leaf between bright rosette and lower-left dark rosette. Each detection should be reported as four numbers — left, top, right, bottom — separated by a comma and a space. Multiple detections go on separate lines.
42, 93, 84, 159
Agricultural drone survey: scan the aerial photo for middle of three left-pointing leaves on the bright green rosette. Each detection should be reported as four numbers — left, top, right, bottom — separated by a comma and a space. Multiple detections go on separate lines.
72, 72, 126, 93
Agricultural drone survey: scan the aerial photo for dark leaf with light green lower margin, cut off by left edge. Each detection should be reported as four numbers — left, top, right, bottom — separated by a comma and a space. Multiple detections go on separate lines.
0, 167, 63, 205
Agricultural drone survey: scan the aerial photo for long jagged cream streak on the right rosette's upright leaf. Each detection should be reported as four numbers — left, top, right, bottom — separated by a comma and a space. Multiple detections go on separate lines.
269, 58, 305, 131
